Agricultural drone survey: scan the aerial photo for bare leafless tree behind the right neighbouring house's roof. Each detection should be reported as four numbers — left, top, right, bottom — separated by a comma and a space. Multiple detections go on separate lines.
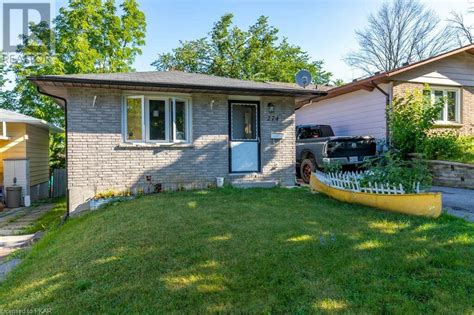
345, 0, 453, 74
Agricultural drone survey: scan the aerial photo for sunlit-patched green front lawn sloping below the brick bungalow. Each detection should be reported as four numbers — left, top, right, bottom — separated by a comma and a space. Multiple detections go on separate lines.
0, 188, 474, 314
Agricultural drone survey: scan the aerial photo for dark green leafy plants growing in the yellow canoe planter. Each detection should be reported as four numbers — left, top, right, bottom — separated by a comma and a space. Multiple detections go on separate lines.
361, 152, 432, 193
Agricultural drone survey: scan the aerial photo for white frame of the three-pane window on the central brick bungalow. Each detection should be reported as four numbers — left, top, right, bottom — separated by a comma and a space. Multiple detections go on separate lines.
122, 95, 193, 145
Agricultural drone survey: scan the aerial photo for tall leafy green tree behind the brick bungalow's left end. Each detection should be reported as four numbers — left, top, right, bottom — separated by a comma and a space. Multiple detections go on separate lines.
8, 0, 146, 165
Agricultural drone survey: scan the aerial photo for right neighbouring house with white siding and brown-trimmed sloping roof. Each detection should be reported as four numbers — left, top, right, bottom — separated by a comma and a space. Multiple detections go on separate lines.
296, 44, 474, 139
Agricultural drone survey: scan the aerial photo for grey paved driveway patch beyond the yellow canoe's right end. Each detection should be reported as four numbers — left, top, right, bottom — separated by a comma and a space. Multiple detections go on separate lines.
431, 186, 474, 222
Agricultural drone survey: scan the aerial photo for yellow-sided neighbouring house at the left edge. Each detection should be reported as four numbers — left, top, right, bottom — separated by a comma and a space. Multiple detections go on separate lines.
0, 109, 62, 206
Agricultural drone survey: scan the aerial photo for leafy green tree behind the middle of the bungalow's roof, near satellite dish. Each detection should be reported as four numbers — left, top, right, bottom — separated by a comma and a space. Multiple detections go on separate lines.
152, 14, 332, 84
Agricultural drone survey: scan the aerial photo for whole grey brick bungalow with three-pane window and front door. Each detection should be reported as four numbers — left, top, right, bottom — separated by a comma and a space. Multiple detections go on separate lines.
29, 71, 323, 212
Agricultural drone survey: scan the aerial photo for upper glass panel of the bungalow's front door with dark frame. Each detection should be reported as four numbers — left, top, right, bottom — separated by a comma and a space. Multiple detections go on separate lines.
232, 104, 257, 140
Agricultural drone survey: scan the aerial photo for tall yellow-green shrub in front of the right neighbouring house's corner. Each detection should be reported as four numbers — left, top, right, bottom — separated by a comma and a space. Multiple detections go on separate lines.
387, 85, 443, 157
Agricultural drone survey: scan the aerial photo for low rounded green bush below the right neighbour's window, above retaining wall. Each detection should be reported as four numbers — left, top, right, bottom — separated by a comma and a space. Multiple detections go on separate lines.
423, 130, 463, 160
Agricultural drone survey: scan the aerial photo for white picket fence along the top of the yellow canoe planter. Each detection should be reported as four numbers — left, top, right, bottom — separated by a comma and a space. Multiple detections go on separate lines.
315, 171, 420, 195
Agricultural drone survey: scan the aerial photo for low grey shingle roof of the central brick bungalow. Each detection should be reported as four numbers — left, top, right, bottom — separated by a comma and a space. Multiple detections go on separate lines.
29, 71, 321, 95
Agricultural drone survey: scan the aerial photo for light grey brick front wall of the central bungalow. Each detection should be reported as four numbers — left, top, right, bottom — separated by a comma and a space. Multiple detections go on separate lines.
68, 89, 295, 211
